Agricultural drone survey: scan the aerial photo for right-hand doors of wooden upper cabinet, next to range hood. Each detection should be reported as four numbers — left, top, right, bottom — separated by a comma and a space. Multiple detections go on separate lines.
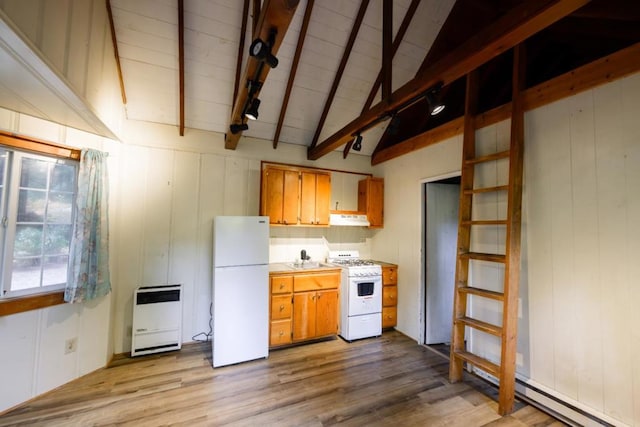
300, 172, 331, 225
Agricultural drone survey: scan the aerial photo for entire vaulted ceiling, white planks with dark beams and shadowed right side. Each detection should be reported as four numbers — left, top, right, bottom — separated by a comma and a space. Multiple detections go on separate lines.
7, 0, 640, 164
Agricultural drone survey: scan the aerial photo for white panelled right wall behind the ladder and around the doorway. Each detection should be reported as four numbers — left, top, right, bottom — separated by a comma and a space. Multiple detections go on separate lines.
372, 74, 640, 426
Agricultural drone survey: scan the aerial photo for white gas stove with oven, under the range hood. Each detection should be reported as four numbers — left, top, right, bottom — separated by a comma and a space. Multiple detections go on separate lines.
327, 251, 382, 341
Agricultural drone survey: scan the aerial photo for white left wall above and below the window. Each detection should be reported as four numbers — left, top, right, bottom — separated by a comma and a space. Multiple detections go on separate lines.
0, 109, 118, 412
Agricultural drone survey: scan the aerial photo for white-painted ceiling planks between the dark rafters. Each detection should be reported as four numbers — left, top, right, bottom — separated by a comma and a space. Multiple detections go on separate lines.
111, 0, 454, 154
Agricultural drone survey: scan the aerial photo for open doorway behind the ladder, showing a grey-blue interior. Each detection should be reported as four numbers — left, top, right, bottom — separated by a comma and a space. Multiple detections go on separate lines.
421, 174, 460, 357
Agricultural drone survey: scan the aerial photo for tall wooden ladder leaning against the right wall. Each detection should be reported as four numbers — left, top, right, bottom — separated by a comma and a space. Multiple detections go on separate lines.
449, 46, 525, 415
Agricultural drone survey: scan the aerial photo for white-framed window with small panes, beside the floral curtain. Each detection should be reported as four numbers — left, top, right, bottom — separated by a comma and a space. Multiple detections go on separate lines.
0, 147, 78, 297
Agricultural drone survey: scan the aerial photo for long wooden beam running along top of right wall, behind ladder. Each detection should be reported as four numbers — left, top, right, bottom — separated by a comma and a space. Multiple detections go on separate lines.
371, 43, 640, 165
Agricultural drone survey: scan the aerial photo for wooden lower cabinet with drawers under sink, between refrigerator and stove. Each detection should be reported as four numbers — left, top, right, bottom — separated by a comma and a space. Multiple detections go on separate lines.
269, 269, 340, 347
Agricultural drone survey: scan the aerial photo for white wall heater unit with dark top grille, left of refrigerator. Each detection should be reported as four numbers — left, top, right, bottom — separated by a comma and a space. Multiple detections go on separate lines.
131, 285, 182, 356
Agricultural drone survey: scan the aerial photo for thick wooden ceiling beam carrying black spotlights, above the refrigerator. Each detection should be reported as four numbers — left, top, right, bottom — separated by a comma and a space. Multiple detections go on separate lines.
224, 0, 300, 150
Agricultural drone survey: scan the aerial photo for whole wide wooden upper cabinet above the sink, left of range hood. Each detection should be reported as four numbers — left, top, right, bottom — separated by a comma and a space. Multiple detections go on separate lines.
260, 166, 331, 226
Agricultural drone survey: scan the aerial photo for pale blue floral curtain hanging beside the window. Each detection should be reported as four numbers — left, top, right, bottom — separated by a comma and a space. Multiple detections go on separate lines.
64, 149, 111, 302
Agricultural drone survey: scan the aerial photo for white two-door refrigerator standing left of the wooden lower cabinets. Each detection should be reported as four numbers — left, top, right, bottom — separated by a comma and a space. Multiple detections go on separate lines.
212, 216, 269, 368
